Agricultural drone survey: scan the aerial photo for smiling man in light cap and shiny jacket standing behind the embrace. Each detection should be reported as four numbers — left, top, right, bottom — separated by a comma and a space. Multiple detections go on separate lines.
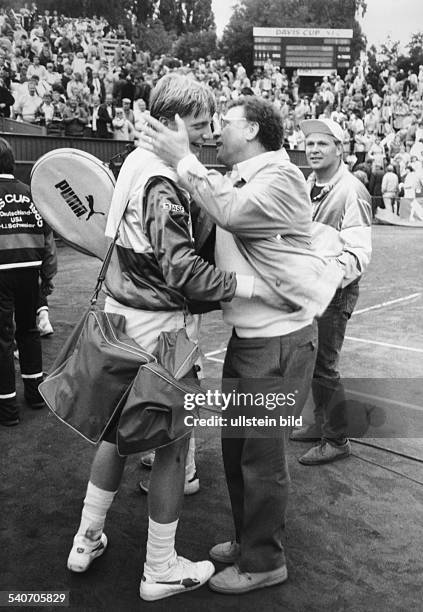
290, 119, 372, 465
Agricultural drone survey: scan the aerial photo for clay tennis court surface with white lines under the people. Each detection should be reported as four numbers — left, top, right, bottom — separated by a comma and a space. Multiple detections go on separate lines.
0, 226, 423, 612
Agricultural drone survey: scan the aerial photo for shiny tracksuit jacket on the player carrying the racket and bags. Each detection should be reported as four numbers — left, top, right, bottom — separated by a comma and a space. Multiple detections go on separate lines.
105, 148, 237, 312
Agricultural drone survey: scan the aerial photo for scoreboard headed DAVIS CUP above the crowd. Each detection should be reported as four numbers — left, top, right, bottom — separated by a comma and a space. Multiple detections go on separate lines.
253, 28, 353, 76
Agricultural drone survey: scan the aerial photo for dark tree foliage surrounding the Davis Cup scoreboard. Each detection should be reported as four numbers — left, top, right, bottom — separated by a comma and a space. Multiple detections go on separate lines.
221, 0, 367, 71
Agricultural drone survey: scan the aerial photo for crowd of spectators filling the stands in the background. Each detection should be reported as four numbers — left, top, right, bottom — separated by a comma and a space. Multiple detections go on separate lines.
0, 4, 423, 212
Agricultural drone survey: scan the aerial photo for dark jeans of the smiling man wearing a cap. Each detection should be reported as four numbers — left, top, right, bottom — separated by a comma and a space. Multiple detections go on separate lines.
312, 281, 359, 443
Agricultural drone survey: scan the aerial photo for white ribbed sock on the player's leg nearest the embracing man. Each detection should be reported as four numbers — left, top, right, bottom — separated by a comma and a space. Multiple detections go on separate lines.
144, 518, 178, 579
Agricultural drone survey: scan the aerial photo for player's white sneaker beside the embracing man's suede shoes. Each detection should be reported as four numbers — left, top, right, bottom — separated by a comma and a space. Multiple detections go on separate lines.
140, 556, 215, 601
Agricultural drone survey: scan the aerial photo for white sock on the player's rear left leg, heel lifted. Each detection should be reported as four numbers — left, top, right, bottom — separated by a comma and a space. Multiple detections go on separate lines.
78, 482, 117, 540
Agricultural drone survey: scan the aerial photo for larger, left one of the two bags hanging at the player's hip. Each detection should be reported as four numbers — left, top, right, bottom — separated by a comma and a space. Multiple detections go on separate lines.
39, 305, 156, 444
